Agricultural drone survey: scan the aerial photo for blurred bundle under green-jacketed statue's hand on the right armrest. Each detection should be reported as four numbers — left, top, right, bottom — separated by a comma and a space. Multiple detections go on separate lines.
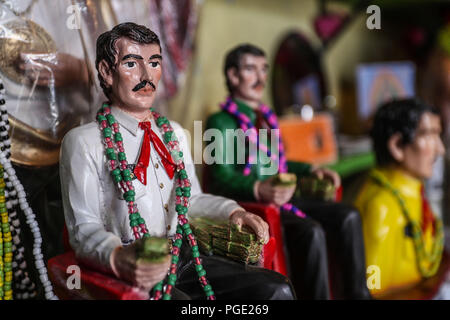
300, 176, 336, 201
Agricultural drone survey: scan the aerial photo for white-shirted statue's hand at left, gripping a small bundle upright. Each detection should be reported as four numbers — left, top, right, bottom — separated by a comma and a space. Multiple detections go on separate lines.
110, 242, 171, 291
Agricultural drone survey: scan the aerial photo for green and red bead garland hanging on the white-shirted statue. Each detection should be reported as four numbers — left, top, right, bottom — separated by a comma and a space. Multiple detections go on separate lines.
97, 103, 215, 300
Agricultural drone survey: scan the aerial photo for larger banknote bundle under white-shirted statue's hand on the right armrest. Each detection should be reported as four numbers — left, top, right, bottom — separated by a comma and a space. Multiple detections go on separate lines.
191, 218, 263, 263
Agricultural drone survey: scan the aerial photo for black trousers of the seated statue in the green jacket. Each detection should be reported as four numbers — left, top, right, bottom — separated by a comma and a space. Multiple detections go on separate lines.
281, 199, 371, 299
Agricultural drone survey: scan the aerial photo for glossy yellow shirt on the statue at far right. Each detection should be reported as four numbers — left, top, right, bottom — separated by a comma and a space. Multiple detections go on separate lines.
355, 168, 433, 296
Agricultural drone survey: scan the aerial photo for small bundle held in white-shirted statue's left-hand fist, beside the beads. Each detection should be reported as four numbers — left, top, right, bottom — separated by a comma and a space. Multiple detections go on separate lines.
135, 237, 169, 263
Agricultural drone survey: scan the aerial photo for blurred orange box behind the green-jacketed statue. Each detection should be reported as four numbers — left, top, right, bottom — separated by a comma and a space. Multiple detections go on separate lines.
279, 113, 338, 165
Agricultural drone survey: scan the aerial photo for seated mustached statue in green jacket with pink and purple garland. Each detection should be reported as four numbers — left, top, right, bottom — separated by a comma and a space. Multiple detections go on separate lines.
205, 44, 370, 299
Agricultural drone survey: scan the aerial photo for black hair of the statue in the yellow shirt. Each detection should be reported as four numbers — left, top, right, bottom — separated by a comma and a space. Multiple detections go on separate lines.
370, 98, 438, 166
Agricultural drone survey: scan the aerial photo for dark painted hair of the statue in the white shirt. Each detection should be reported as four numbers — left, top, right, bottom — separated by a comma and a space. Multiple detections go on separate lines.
95, 22, 161, 98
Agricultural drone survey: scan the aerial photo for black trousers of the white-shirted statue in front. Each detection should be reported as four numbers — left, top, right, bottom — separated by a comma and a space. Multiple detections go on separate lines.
172, 242, 296, 300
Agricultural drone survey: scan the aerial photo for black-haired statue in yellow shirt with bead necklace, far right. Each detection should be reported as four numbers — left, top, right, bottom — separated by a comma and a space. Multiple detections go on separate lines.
355, 99, 444, 297
